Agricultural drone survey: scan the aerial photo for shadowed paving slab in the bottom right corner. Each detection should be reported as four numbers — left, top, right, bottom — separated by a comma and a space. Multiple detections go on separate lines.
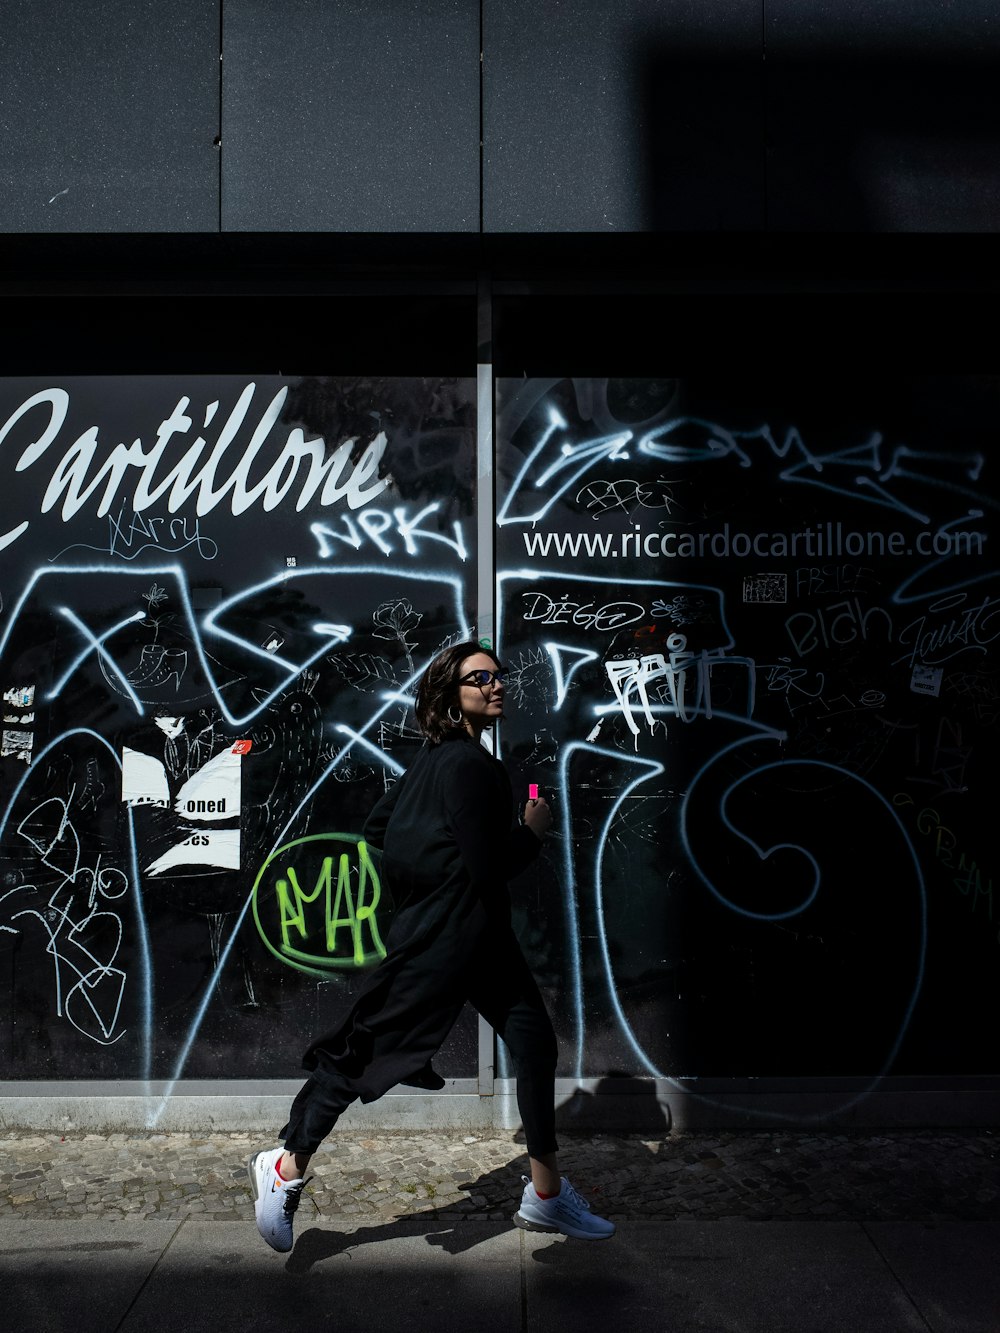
865, 1222, 1000, 1333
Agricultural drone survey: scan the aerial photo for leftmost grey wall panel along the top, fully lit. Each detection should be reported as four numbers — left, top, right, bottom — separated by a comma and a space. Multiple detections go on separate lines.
0, 0, 219, 232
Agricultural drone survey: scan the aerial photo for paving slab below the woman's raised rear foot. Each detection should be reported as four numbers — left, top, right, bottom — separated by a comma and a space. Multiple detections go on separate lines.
120, 1220, 521, 1333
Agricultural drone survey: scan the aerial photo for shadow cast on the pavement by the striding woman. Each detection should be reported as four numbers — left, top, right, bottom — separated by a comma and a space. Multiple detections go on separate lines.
285, 1077, 671, 1273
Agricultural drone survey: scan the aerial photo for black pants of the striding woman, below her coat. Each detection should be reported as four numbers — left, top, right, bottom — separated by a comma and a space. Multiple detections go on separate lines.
279, 950, 559, 1157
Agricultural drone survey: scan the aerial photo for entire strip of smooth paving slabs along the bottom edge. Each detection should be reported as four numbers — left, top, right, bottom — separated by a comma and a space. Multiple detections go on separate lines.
0, 1221, 1000, 1333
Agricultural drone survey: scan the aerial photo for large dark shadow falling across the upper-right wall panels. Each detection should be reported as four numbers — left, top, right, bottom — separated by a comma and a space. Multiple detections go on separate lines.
640, 47, 1000, 233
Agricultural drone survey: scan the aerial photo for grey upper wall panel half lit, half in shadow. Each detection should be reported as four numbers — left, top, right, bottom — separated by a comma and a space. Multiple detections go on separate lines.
483, 0, 763, 232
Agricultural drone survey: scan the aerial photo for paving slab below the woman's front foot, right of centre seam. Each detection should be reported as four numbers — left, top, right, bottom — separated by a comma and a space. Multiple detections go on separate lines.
524, 1218, 927, 1333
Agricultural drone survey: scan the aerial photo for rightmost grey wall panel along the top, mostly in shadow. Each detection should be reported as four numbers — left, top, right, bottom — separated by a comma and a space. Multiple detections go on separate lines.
765, 0, 1000, 232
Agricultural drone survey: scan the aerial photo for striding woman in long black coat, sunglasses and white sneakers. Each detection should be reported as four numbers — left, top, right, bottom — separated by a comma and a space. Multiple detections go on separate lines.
248, 641, 615, 1252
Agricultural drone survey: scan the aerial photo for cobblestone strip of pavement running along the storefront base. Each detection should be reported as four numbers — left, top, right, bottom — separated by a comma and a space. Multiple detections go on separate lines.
0, 1130, 1000, 1225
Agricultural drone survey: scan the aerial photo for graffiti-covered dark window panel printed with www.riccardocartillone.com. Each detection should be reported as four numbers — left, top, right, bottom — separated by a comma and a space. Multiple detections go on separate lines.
497, 373, 1000, 1081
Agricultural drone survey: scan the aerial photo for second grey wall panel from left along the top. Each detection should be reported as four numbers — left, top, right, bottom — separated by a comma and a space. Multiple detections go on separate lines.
223, 0, 479, 232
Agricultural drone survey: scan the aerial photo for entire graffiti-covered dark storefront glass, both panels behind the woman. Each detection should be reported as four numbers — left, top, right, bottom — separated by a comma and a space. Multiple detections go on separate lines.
0, 375, 1000, 1114
